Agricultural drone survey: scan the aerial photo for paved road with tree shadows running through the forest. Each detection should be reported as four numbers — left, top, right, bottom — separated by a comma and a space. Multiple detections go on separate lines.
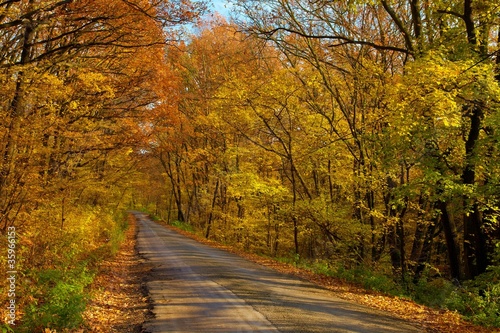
134, 213, 421, 333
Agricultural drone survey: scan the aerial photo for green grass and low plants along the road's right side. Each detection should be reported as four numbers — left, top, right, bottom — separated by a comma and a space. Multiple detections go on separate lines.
277, 257, 500, 328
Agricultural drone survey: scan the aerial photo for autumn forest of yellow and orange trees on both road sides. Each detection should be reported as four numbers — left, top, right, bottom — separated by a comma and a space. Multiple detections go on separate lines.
0, 0, 500, 332
